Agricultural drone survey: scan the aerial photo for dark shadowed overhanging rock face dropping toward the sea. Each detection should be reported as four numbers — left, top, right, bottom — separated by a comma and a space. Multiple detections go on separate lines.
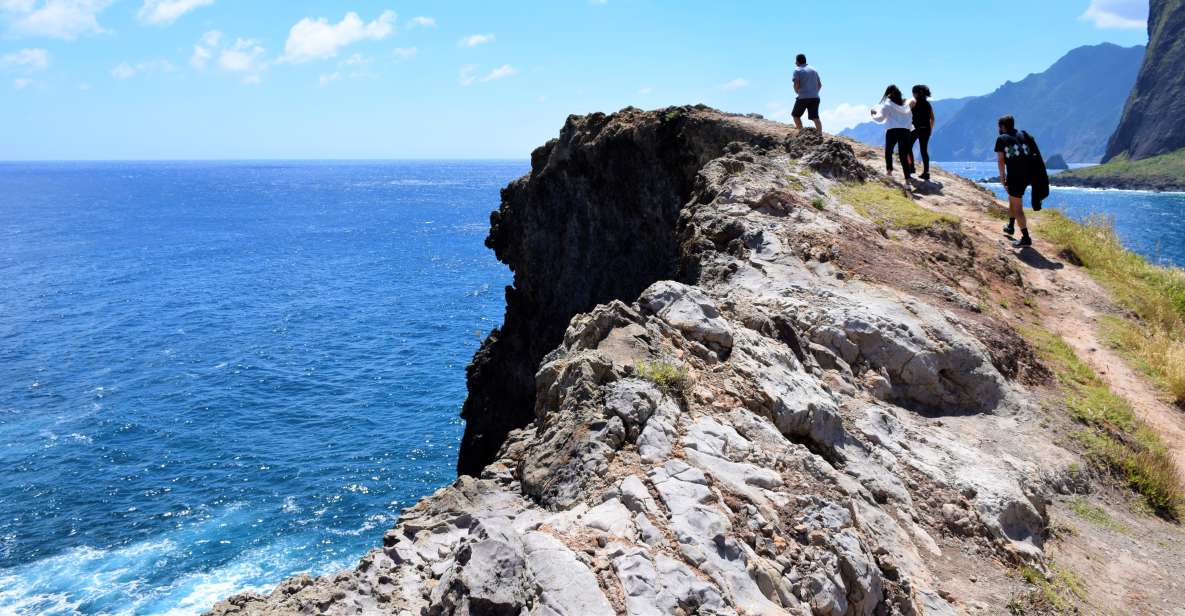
457, 107, 781, 475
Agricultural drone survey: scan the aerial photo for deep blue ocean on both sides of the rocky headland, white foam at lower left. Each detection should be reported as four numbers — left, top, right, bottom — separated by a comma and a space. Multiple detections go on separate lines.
0, 161, 1185, 615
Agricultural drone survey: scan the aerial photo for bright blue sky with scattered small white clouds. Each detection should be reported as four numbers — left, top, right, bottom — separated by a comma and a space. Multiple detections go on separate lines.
0, 0, 1147, 160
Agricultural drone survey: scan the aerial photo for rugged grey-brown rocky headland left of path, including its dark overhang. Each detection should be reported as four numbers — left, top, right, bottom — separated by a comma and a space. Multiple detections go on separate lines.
212, 107, 1185, 616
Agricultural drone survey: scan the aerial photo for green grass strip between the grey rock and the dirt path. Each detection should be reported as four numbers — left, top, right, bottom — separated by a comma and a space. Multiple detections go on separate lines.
1023, 327, 1185, 520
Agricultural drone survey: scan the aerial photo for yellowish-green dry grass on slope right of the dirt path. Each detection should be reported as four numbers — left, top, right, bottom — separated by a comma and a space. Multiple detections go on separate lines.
1038, 211, 1185, 404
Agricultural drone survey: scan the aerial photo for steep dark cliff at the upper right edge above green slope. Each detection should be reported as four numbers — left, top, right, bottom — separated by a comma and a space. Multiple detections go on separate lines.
1103, 0, 1185, 162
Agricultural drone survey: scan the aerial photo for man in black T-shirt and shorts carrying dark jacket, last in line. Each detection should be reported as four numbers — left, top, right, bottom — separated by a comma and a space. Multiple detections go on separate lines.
995, 115, 1049, 248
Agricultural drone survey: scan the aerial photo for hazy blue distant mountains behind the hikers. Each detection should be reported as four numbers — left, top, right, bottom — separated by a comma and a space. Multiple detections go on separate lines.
841, 43, 1145, 162
